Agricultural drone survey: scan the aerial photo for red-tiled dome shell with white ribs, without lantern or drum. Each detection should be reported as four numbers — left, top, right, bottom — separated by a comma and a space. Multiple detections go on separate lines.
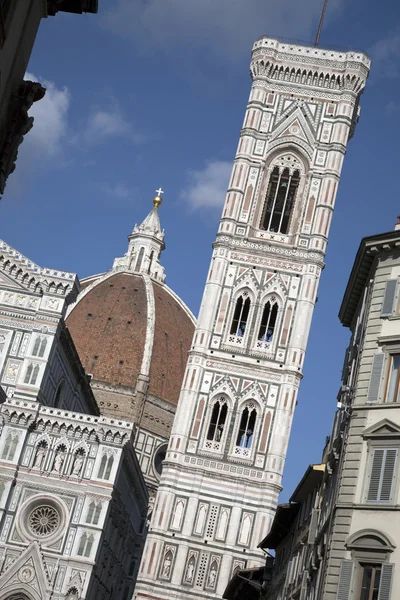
67, 271, 195, 408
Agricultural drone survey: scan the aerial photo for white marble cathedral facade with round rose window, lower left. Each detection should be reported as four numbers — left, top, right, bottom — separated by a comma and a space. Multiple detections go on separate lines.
0, 241, 148, 600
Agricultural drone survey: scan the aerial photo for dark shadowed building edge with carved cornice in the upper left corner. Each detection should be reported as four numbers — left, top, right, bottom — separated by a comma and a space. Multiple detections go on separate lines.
0, 0, 97, 196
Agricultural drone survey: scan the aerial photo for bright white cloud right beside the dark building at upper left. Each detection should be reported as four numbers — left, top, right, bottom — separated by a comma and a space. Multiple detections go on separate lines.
24, 73, 71, 158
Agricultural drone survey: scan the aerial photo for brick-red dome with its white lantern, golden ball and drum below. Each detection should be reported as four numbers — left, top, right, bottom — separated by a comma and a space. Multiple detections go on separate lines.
67, 195, 195, 497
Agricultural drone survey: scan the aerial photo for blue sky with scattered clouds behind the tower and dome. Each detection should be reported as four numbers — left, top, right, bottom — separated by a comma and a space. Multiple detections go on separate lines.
0, 0, 400, 500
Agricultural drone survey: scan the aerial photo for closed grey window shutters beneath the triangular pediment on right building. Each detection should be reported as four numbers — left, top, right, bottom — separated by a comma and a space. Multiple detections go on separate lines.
367, 448, 398, 504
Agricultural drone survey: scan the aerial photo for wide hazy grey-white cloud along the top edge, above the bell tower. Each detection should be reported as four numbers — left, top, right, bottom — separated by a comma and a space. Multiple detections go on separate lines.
102, 0, 342, 58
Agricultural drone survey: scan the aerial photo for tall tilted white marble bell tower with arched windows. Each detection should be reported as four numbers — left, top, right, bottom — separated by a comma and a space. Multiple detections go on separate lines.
134, 37, 370, 600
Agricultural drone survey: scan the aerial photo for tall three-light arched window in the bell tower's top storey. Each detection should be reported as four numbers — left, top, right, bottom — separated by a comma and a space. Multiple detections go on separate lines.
260, 167, 300, 233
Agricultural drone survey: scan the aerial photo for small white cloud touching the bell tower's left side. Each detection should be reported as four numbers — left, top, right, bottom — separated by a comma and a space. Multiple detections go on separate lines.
181, 160, 232, 210
